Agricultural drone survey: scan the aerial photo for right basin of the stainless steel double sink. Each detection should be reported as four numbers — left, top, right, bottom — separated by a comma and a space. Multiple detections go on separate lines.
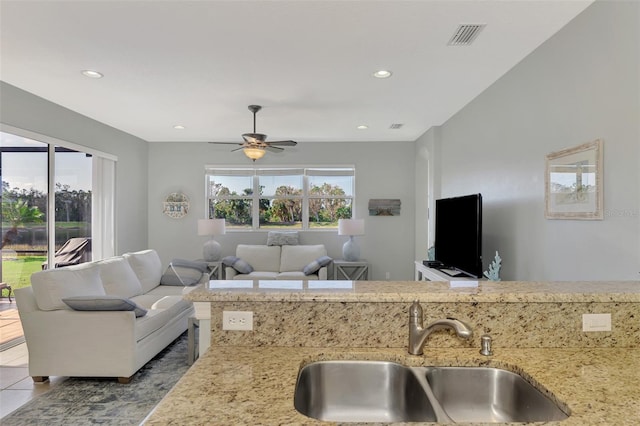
425, 367, 568, 423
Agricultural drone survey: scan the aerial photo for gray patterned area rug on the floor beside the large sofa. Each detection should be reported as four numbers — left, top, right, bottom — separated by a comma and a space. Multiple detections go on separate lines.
0, 332, 189, 426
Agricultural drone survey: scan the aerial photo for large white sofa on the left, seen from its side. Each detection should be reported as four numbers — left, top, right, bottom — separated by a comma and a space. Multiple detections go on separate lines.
15, 250, 208, 383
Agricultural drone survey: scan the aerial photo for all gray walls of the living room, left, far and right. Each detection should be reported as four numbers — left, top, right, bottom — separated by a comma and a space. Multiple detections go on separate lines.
0, 1, 640, 280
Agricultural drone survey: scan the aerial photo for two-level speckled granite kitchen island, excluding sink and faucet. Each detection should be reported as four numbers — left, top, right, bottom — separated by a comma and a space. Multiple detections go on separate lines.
146, 282, 640, 425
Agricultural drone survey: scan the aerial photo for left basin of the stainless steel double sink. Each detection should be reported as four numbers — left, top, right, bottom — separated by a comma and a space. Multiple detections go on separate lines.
293, 361, 437, 422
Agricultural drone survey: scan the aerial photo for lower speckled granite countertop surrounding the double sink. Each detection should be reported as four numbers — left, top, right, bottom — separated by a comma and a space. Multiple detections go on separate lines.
145, 347, 640, 426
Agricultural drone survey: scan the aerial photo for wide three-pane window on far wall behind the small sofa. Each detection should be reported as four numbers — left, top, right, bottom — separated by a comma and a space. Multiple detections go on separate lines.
206, 167, 355, 230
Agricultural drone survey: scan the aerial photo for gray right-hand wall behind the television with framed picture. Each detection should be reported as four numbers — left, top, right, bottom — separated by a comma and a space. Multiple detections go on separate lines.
428, 1, 640, 280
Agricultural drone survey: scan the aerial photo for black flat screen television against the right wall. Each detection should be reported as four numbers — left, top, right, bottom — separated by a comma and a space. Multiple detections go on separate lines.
434, 194, 482, 278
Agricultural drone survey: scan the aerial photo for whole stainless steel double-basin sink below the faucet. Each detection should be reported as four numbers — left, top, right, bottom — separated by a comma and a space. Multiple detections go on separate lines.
294, 361, 568, 423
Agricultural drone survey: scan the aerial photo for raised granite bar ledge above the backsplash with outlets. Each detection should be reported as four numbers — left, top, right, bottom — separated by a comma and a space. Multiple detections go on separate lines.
185, 280, 640, 303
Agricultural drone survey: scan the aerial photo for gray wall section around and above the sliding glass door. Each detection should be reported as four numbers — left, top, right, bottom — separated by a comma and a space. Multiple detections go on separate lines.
0, 81, 147, 253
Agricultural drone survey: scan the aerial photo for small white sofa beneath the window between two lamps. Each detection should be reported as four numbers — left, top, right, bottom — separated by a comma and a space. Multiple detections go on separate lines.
225, 244, 327, 280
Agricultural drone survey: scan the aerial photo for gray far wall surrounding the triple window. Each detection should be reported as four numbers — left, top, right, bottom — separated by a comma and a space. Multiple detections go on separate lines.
148, 141, 415, 280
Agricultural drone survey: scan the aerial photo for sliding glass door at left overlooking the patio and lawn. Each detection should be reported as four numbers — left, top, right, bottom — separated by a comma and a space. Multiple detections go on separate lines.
0, 132, 107, 289
